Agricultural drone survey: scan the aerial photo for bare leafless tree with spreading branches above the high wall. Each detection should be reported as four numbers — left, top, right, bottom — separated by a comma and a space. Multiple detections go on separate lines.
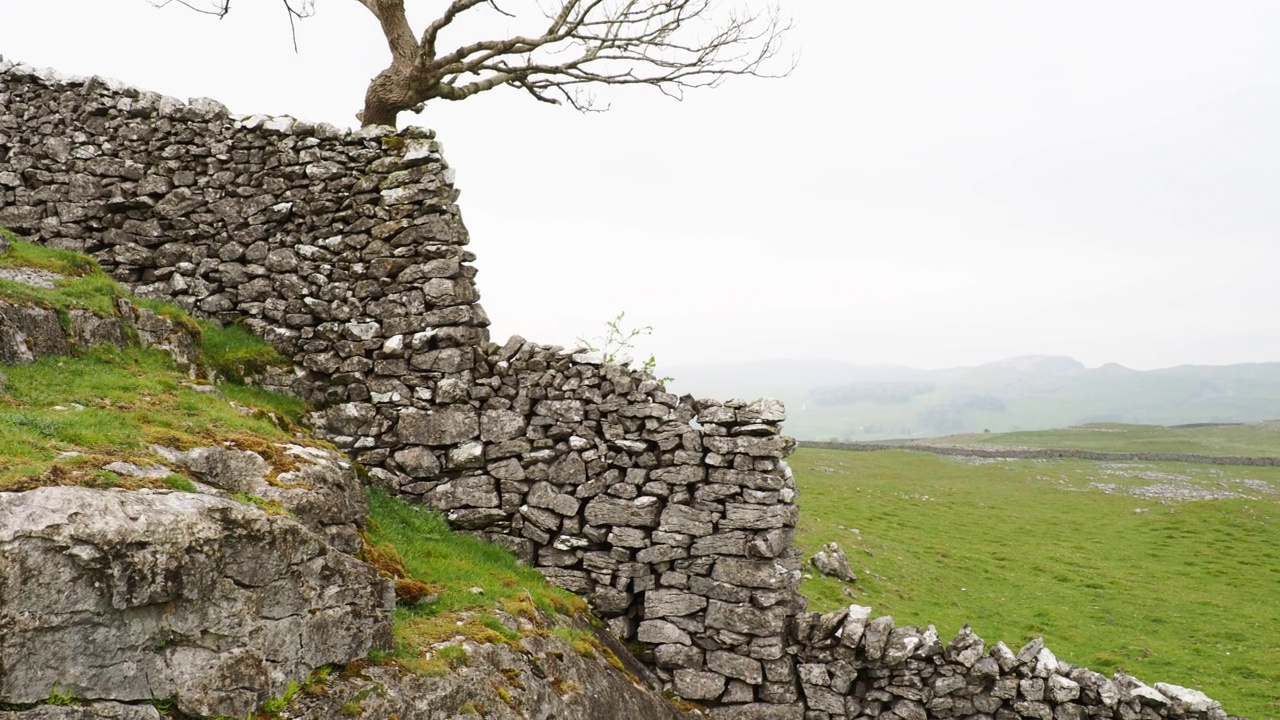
152, 0, 795, 126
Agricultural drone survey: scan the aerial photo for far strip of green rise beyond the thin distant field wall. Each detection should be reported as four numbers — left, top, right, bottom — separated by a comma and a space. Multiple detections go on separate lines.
922, 420, 1280, 457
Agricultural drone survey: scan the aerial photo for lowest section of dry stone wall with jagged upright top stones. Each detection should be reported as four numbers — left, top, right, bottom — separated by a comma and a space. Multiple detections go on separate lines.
791, 605, 1226, 720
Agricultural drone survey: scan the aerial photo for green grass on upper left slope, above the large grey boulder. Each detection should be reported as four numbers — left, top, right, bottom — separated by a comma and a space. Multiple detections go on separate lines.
0, 233, 306, 492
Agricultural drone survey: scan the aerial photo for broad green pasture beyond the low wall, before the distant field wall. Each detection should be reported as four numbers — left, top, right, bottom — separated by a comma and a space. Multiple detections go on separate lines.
791, 448, 1280, 720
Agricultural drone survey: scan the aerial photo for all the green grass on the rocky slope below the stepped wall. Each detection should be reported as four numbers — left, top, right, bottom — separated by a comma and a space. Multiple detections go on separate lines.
0, 234, 604, 702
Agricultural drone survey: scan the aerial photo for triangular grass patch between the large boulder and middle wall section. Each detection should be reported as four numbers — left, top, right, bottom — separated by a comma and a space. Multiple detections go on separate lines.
366, 488, 586, 674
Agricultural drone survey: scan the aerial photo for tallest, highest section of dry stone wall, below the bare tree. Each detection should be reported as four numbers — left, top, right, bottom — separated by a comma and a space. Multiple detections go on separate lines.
0, 55, 489, 414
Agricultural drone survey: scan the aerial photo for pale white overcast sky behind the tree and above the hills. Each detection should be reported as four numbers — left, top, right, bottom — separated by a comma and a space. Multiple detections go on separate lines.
0, 0, 1280, 369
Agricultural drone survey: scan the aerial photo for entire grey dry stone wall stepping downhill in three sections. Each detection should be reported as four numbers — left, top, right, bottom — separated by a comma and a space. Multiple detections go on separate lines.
0, 60, 1225, 720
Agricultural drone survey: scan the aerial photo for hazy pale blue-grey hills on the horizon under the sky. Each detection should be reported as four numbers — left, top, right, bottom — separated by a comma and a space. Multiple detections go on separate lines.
659, 356, 1280, 441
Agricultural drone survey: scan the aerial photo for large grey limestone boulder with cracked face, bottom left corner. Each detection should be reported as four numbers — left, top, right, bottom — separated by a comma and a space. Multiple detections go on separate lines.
0, 487, 394, 716
